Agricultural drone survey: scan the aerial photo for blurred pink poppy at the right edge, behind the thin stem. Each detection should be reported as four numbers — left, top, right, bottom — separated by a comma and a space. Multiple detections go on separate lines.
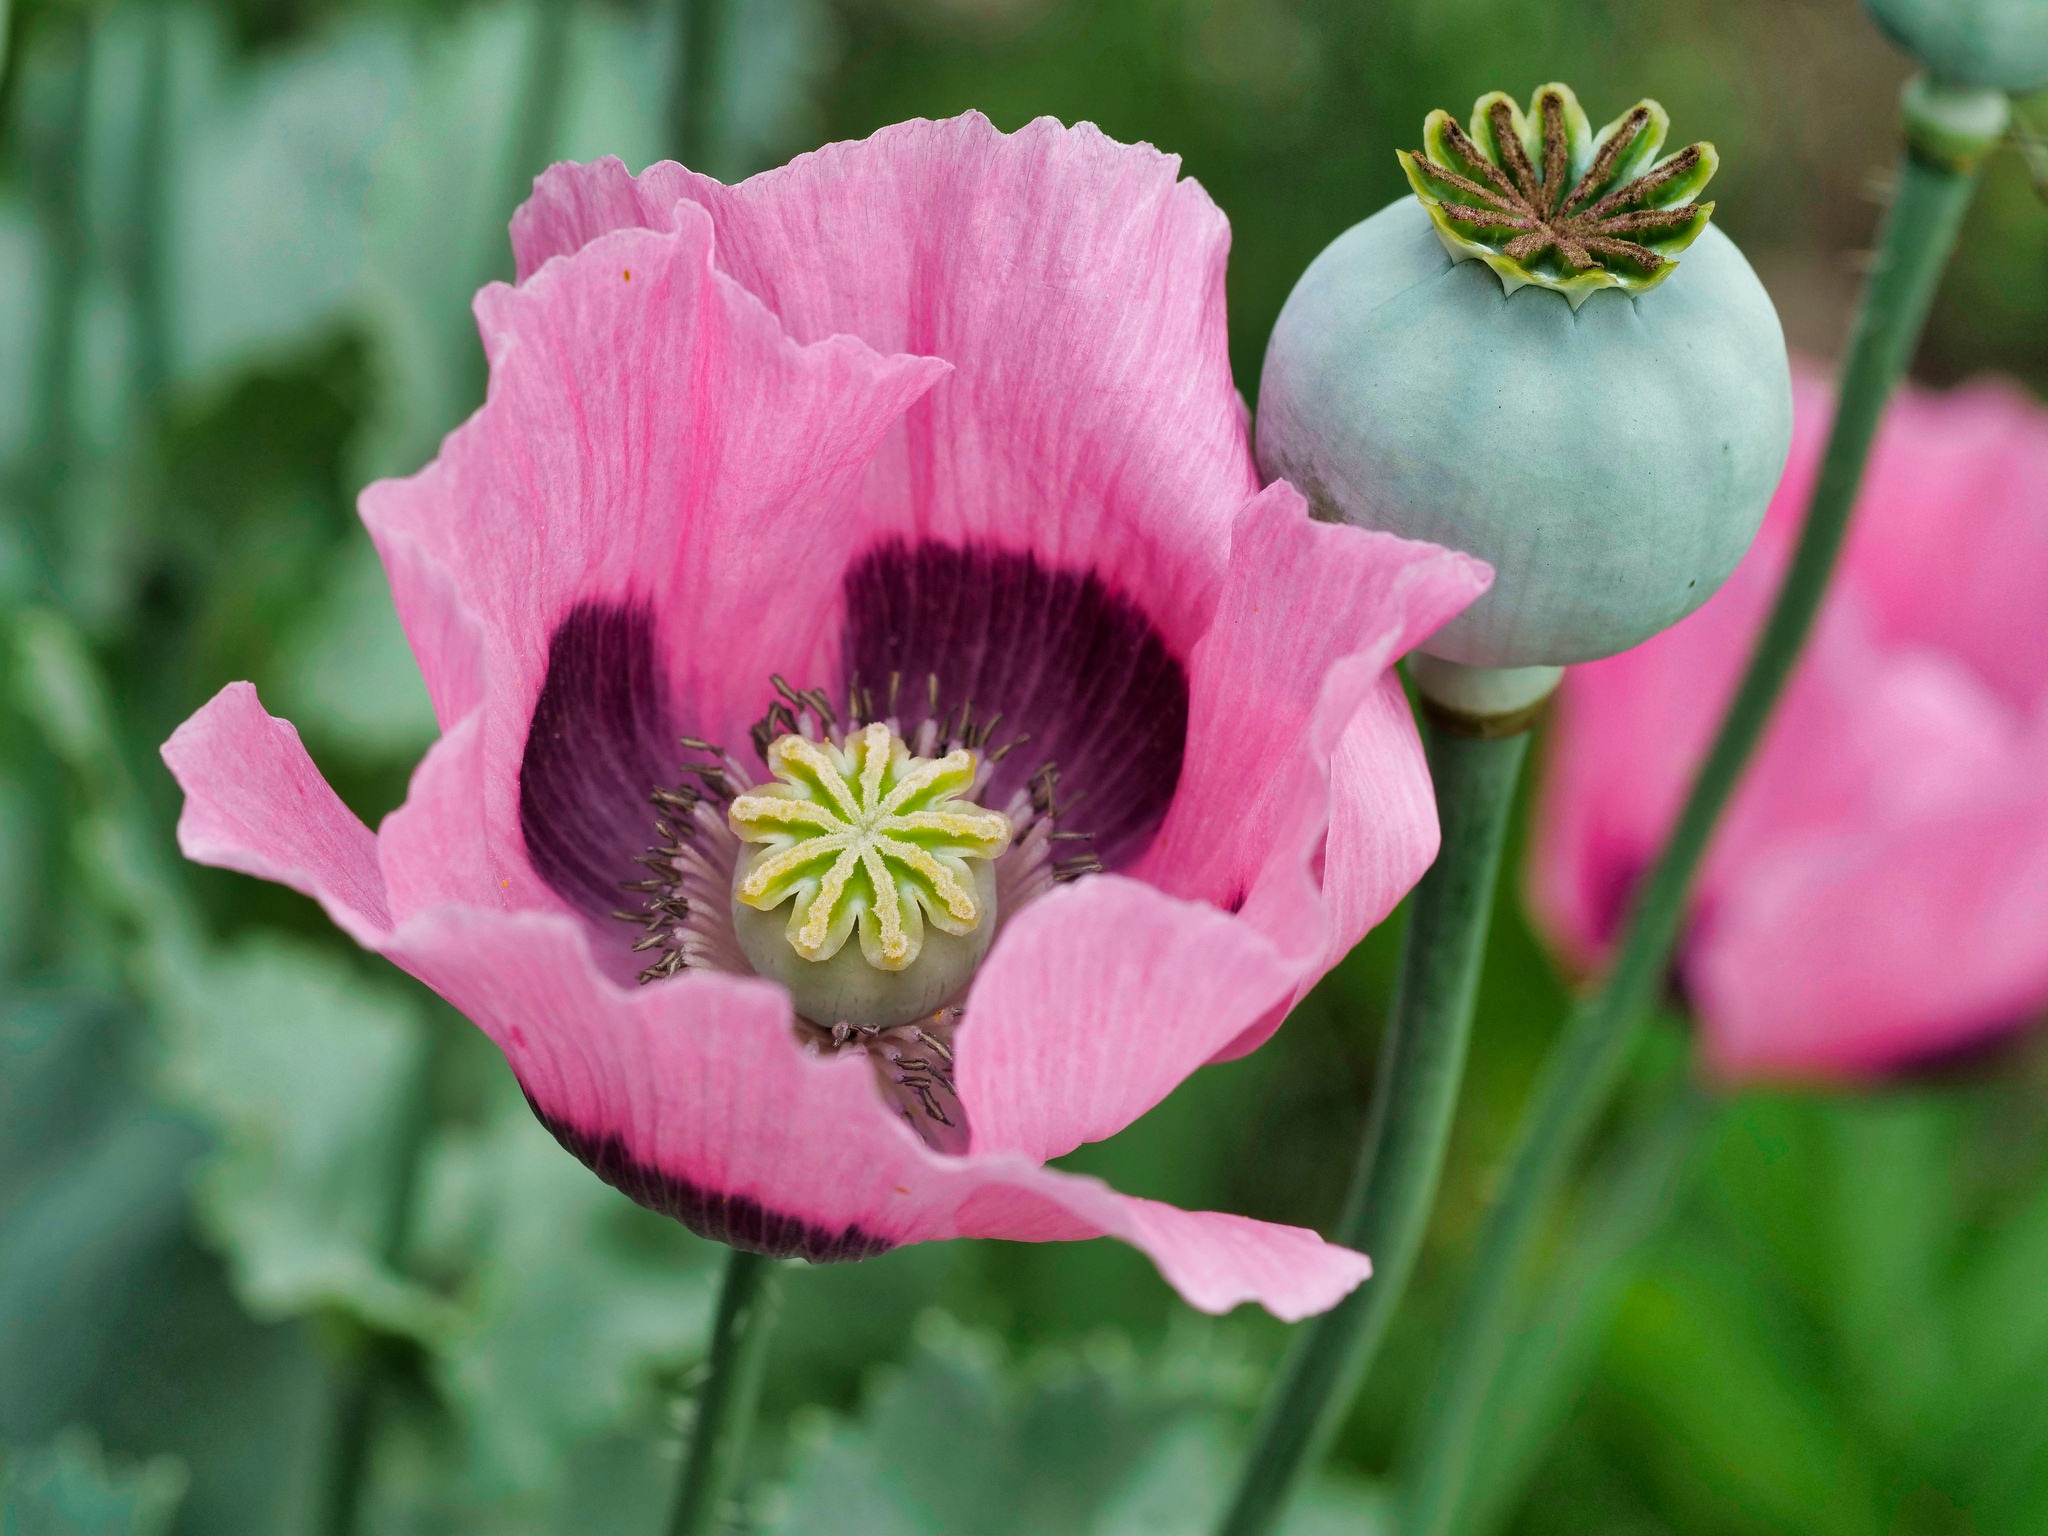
1530, 375, 2048, 1079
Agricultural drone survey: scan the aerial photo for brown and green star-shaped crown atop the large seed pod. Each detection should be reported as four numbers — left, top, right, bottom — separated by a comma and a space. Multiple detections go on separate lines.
1399, 84, 1718, 309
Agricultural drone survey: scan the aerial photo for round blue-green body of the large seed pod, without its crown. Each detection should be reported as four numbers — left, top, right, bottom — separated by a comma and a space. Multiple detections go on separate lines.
1257, 197, 1792, 668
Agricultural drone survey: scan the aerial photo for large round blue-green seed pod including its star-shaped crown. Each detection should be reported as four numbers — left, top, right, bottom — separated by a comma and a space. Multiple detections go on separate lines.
1257, 84, 1792, 668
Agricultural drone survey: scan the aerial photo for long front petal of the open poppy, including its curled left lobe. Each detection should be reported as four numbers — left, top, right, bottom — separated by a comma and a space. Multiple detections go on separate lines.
164, 684, 1370, 1319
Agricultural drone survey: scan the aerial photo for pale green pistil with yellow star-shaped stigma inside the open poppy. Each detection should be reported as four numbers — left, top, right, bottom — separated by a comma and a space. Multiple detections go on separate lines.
727, 723, 1012, 1022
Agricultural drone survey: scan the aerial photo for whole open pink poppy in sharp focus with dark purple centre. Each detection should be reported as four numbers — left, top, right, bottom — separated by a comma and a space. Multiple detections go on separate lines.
164, 117, 1487, 1319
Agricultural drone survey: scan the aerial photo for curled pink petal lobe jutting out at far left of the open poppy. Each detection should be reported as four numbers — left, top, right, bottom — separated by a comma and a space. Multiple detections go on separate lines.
164, 682, 391, 946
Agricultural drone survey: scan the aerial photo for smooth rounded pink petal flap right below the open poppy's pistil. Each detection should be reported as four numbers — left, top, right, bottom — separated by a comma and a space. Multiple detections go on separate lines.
956, 874, 1298, 1163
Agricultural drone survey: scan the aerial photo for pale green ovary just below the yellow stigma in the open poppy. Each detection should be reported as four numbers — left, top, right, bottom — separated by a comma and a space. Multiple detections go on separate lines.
733, 858, 997, 1030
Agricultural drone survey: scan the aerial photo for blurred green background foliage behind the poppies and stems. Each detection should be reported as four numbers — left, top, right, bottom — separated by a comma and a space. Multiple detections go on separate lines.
0, 0, 2048, 1536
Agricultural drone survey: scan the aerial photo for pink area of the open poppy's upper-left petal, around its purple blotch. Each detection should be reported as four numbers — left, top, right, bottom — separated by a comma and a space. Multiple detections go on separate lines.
362, 209, 944, 918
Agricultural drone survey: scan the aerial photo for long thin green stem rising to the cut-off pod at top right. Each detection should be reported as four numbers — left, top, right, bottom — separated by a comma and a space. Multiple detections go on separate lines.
1401, 80, 2003, 1536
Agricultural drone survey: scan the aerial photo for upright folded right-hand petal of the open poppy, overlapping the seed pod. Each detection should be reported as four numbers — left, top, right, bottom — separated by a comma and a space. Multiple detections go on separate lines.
1135, 481, 1491, 1055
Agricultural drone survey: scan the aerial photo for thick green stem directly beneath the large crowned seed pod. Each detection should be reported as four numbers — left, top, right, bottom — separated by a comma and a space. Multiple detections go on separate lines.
1221, 725, 1528, 1536
